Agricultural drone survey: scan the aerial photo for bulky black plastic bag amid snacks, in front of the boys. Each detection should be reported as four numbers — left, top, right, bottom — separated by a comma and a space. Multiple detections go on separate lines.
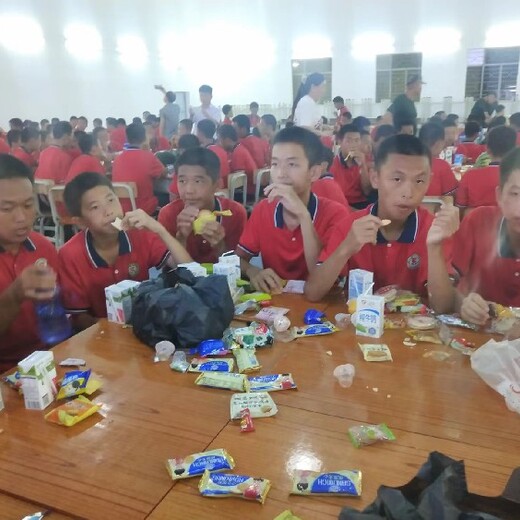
130, 268, 235, 348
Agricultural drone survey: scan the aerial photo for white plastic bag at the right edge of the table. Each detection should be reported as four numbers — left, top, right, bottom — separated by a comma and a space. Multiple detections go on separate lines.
471, 339, 520, 413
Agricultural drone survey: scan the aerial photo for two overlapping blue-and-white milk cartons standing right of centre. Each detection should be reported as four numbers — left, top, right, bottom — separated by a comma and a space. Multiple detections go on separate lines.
348, 269, 385, 338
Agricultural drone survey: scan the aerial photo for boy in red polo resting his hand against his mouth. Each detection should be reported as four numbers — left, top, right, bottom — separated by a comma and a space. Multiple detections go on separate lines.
236, 126, 348, 292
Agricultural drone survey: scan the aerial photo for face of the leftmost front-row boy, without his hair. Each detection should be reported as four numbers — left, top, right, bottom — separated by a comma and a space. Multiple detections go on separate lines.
0, 178, 36, 248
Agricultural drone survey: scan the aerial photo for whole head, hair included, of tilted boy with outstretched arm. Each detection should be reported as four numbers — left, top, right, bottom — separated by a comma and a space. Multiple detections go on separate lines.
63, 172, 123, 236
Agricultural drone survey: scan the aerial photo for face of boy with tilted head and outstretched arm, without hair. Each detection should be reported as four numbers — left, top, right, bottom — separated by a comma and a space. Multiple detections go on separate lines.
76, 186, 123, 235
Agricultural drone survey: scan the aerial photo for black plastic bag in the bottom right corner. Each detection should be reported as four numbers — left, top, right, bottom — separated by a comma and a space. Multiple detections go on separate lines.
339, 452, 520, 520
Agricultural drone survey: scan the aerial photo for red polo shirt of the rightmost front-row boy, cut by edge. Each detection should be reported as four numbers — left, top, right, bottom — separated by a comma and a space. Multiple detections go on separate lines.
453, 206, 520, 307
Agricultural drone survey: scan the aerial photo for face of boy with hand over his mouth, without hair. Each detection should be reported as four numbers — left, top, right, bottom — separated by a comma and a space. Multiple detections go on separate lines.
271, 143, 321, 196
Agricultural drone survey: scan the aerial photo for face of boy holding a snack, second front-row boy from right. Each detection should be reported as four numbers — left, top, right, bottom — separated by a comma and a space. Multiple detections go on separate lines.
370, 153, 431, 222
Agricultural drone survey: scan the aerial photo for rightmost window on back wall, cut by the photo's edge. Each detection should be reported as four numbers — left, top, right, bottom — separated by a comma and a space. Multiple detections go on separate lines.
466, 47, 520, 100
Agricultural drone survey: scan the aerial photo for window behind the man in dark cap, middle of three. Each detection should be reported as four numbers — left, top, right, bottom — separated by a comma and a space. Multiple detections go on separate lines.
376, 52, 422, 103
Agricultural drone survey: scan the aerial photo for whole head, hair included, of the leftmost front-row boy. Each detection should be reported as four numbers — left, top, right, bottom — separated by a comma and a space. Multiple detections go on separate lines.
0, 154, 36, 250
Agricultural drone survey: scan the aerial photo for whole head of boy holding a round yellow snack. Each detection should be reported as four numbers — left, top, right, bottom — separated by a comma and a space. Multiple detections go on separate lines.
175, 146, 220, 209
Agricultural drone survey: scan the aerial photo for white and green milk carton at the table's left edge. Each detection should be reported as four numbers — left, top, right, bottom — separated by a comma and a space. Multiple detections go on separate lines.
18, 350, 57, 410
